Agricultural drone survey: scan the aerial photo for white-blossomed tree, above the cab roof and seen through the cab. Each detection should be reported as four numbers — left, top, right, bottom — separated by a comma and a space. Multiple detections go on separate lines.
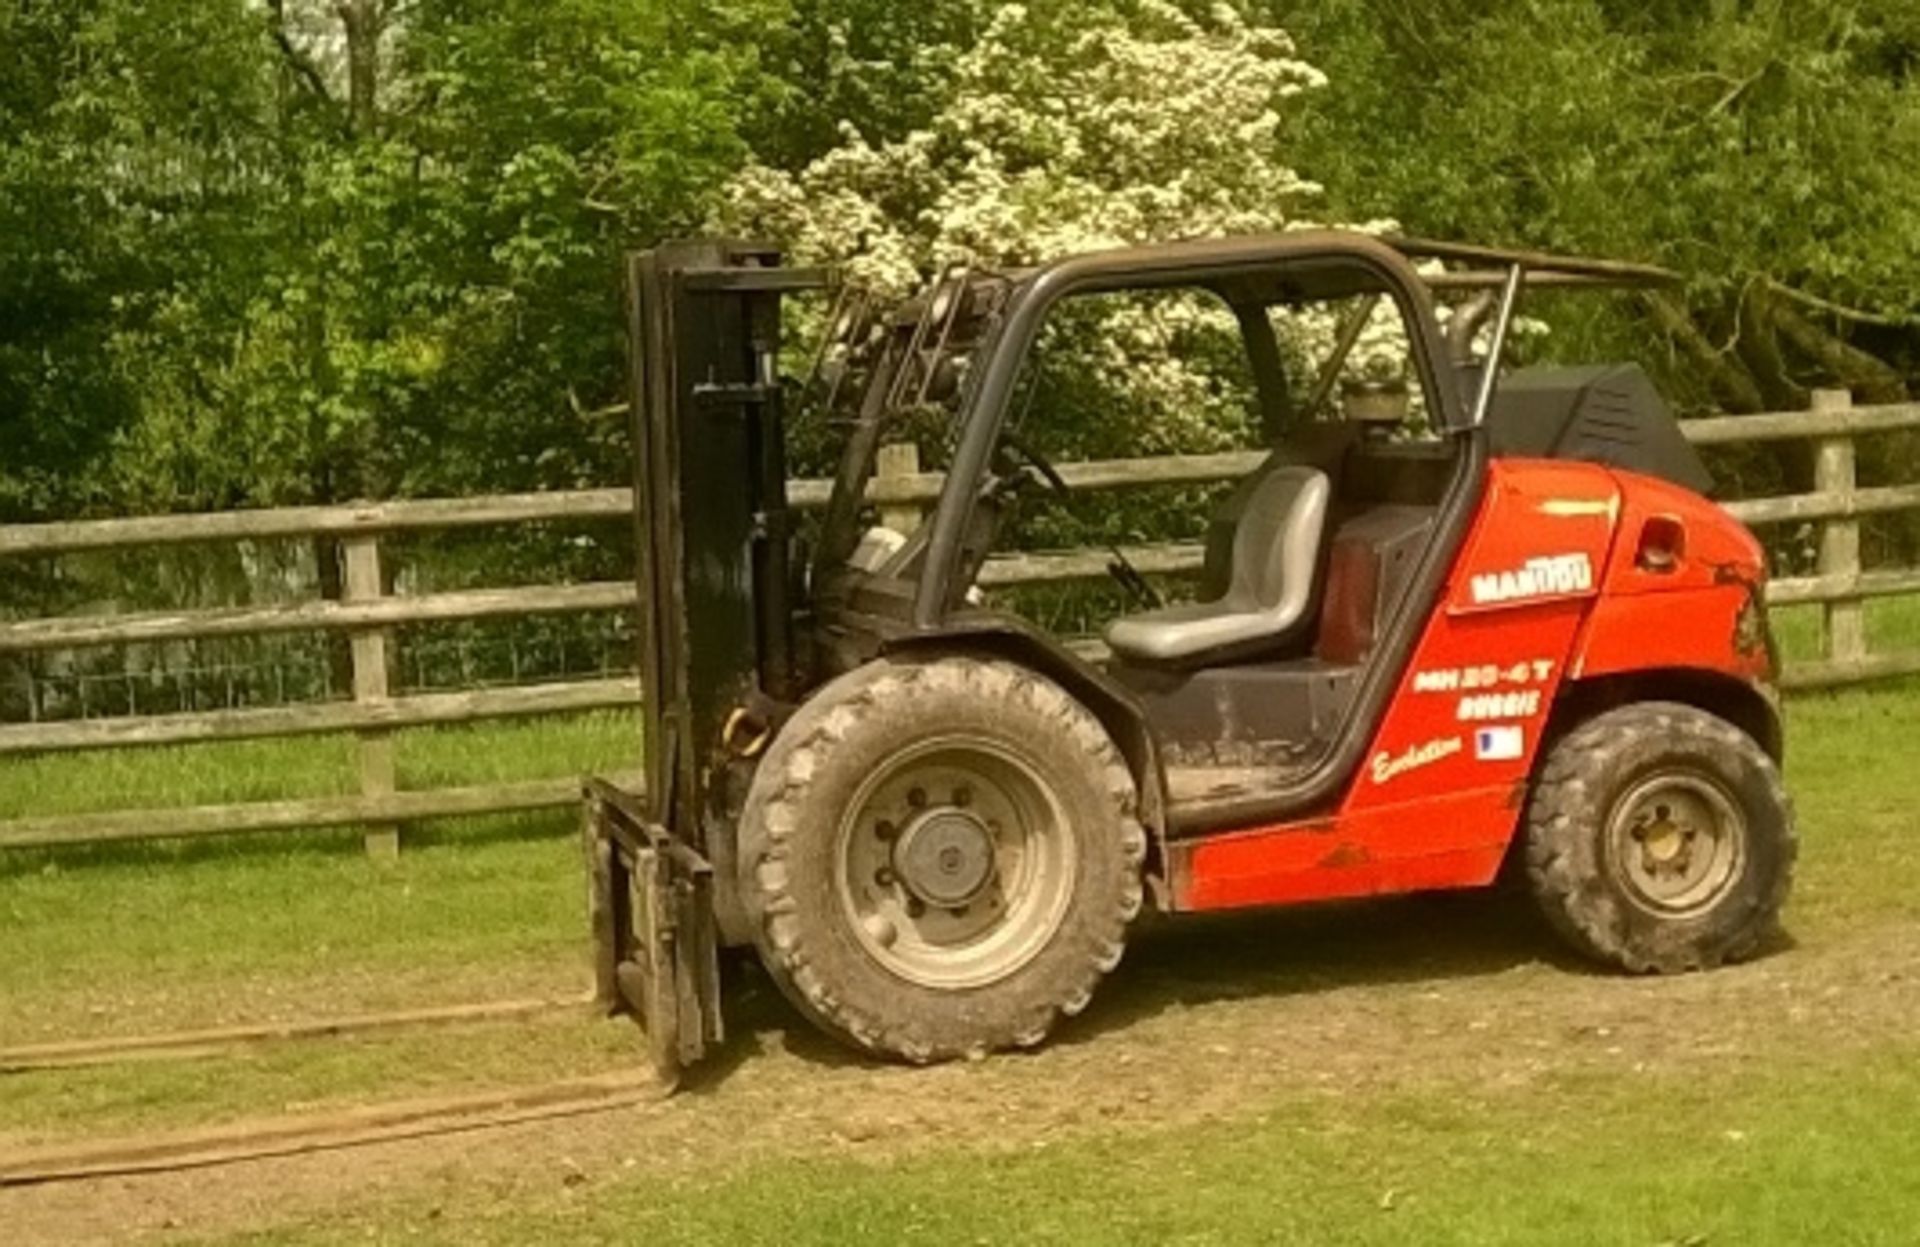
716, 0, 1351, 466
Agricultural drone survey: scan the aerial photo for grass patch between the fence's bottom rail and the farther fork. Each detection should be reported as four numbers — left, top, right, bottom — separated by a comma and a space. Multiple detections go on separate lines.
0, 815, 582, 1041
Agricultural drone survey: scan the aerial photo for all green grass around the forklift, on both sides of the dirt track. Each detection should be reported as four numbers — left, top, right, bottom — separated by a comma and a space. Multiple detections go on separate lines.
0, 680, 1920, 1245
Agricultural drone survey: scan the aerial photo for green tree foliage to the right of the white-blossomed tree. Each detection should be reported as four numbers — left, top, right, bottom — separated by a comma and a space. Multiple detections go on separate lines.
1263, 0, 1920, 407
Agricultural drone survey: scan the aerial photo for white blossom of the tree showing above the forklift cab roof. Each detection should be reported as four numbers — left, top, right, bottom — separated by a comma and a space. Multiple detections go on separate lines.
720, 0, 1325, 292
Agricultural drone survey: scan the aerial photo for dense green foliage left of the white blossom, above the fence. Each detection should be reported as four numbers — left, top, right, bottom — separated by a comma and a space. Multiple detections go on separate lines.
0, 0, 768, 517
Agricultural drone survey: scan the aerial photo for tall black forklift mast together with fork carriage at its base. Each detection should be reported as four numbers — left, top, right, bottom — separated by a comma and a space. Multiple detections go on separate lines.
586, 242, 820, 1080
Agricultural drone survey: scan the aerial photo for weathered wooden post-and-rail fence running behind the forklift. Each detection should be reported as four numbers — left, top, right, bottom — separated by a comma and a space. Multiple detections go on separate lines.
0, 392, 1920, 853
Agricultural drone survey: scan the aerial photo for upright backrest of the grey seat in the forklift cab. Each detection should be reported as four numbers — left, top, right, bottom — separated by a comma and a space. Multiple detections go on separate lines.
1227, 467, 1332, 626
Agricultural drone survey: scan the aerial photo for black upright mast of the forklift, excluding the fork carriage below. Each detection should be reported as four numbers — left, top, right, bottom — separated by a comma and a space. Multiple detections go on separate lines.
628, 242, 808, 826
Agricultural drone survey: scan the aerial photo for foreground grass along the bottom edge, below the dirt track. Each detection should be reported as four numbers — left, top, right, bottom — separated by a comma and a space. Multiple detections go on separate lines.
244, 1047, 1920, 1247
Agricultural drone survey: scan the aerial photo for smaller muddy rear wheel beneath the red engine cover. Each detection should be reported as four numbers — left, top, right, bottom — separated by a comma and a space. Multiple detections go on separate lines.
1526, 701, 1795, 974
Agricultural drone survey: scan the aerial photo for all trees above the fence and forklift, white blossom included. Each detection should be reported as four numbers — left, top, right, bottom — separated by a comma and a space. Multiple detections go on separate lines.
11, 0, 1920, 521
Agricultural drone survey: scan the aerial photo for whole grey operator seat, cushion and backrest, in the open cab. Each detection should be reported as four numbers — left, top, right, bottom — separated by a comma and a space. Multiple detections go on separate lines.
1106, 467, 1332, 663
